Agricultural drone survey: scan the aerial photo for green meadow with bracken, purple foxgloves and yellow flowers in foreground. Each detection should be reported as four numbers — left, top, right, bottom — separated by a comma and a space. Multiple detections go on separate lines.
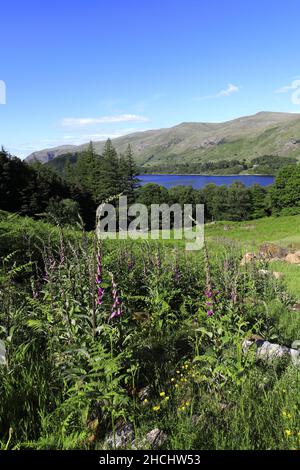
0, 213, 300, 449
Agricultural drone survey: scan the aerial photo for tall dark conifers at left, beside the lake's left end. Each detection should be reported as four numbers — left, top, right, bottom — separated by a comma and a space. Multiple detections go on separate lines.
0, 140, 138, 229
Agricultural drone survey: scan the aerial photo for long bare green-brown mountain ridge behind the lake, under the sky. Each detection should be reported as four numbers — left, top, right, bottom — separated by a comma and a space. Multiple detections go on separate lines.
26, 112, 300, 167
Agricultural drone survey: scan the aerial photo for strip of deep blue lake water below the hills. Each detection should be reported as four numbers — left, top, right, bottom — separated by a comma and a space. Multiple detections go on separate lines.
139, 175, 274, 189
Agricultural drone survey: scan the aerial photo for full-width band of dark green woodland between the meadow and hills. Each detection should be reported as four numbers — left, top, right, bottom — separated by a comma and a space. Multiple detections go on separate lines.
0, 140, 300, 230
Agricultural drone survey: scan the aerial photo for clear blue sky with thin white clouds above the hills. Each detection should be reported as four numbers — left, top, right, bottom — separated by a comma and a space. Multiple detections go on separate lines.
0, 0, 300, 157
